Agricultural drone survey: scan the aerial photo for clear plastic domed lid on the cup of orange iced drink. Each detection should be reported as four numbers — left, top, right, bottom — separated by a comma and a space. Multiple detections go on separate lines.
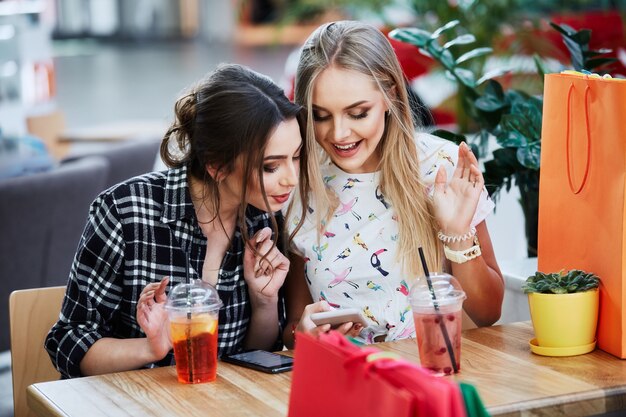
165, 279, 222, 313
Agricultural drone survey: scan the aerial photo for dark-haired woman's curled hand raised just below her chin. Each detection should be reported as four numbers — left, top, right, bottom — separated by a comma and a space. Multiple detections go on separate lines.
243, 227, 289, 305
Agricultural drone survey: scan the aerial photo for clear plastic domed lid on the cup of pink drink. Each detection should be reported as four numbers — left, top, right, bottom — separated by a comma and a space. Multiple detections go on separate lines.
409, 272, 466, 307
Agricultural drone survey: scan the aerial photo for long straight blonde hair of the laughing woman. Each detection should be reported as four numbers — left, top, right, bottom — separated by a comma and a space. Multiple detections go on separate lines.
295, 21, 442, 275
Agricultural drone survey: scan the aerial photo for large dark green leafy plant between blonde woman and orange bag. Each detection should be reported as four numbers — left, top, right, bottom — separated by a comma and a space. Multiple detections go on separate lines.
390, 20, 543, 199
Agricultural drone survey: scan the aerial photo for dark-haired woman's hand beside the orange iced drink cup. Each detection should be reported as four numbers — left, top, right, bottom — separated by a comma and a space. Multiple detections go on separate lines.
137, 277, 172, 361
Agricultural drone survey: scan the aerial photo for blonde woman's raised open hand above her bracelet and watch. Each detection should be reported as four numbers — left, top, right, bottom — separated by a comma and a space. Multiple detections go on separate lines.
433, 142, 485, 235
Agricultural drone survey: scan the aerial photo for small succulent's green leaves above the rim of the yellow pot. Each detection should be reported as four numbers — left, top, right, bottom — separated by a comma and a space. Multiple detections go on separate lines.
522, 269, 600, 294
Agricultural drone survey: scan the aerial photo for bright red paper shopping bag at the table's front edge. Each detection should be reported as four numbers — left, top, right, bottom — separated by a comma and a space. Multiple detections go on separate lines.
289, 331, 466, 417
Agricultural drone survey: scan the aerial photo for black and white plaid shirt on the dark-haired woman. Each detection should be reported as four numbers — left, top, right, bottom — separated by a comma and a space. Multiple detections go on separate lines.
45, 168, 285, 378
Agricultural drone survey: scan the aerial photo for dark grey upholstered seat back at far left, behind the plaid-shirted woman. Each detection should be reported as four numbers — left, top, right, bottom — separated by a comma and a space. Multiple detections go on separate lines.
0, 157, 109, 351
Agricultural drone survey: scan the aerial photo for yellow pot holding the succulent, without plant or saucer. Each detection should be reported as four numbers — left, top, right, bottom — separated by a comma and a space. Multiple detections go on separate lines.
528, 288, 599, 348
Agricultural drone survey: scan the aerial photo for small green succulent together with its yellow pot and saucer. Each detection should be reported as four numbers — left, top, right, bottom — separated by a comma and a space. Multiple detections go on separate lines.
522, 269, 600, 356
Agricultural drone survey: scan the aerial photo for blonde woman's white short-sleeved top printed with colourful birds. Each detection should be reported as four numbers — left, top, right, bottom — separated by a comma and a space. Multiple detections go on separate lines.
288, 134, 494, 343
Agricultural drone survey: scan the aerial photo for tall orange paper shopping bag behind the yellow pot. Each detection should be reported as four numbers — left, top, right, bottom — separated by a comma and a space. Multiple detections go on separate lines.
538, 74, 626, 358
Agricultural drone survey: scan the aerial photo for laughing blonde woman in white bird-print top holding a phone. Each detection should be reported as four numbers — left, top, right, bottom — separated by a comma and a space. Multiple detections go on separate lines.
284, 21, 504, 346
